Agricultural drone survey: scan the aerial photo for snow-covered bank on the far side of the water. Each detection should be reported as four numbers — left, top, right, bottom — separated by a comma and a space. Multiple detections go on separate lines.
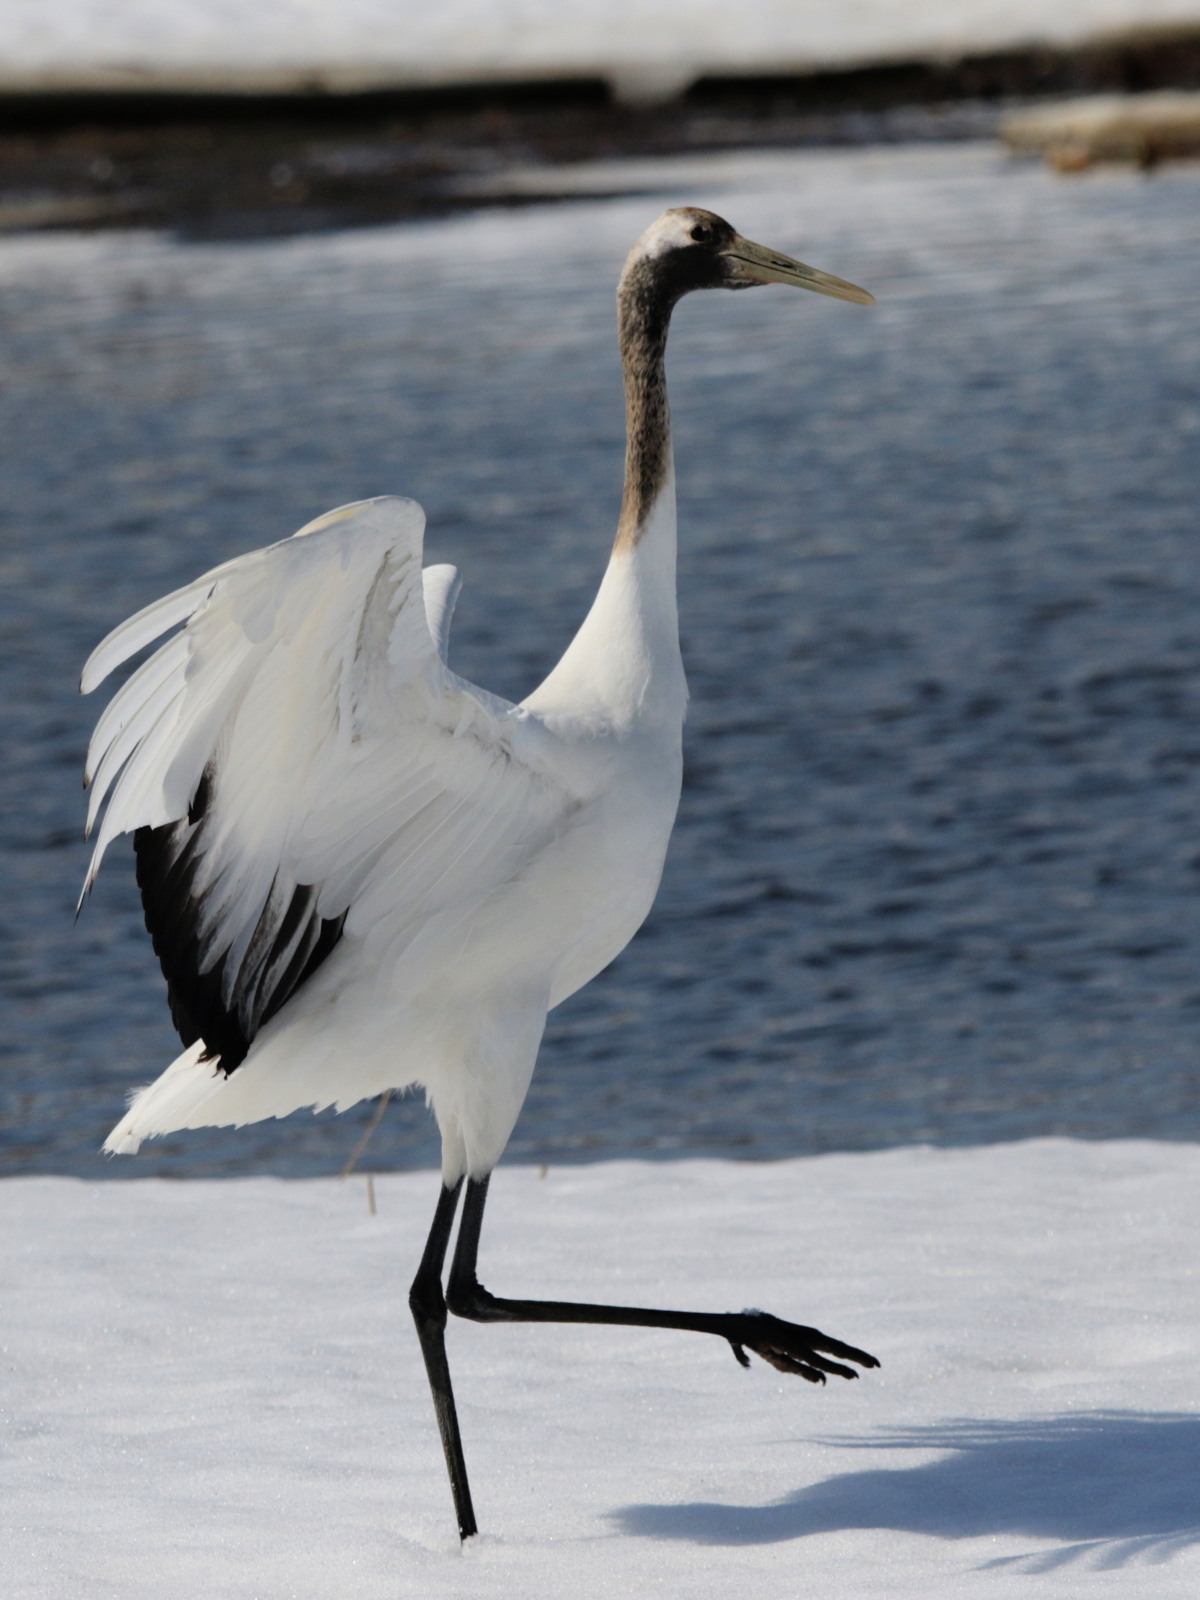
0, 0, 1200, 94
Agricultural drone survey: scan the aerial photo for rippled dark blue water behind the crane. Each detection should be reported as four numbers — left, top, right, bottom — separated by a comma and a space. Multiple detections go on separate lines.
0, 147, 1200, 1176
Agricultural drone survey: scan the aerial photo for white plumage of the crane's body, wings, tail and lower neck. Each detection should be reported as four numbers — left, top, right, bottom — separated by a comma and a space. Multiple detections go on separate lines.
83, 486, 685, 1181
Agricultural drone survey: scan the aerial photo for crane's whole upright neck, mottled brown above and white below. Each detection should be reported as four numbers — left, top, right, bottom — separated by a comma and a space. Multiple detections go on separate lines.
525, 258, 686, 742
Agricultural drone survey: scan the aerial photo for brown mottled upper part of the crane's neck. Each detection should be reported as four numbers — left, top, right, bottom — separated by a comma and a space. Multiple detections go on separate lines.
614, 258, 678, 550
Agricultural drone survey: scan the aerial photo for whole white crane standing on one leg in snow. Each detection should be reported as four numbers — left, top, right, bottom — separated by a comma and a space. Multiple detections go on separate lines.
83, 208, 875, 1538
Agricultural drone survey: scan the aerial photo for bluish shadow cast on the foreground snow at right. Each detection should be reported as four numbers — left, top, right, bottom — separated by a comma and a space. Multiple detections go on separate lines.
614, 1411, 1200, 1571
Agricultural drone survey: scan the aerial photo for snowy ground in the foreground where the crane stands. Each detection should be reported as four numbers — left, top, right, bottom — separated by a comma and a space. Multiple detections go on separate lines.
0, 1139, 1200, 1600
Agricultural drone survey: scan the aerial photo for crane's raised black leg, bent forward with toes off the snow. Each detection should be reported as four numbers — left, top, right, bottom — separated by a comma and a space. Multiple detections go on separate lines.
446, 1178, 878, 1384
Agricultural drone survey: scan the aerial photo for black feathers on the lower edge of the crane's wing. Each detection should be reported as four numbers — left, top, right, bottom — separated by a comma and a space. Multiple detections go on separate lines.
133, 773, 346, 1074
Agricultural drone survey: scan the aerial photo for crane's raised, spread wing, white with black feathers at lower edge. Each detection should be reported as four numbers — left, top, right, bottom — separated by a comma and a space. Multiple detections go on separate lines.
82, 498, 574, 1072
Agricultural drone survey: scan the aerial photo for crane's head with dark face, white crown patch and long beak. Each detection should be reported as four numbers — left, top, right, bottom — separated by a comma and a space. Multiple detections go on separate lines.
622, 205, 875, 306
